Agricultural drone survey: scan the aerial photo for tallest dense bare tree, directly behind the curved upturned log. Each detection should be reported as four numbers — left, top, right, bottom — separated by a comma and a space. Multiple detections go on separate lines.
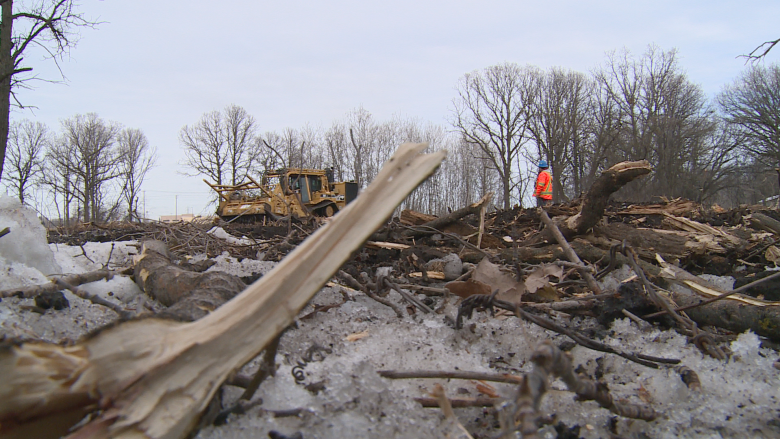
595, 46, 716, 198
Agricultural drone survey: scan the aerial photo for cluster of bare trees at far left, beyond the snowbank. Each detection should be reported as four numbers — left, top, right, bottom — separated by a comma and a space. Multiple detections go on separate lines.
3, 113, 156, 224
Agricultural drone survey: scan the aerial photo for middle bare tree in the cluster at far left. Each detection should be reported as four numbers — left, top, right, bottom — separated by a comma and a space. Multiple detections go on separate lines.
60, 113, 122, 222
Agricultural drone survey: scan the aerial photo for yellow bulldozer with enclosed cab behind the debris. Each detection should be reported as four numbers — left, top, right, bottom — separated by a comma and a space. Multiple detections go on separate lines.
203, 168, 358, 221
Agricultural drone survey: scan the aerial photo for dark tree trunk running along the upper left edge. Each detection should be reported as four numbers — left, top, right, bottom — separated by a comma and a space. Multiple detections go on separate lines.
0, 0, 14, 179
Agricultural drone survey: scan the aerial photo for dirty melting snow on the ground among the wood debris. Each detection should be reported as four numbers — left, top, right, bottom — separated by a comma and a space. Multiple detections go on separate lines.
0, 198, 780, 439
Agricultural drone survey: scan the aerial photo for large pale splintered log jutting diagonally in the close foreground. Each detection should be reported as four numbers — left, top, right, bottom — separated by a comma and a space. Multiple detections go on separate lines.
0, 143, 446, 439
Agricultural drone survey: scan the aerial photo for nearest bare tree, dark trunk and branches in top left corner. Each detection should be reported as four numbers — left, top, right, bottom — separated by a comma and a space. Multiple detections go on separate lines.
0, 0, 97, 177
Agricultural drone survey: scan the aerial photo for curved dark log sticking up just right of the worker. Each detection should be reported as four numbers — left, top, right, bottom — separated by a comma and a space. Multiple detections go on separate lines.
558, 160, 653, 240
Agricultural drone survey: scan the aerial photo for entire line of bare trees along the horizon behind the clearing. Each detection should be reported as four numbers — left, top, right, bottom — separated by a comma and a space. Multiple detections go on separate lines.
3, 46, 780, 221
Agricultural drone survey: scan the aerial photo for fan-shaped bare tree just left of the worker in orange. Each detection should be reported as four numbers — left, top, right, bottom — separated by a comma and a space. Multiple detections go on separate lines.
453, 63, 540, 209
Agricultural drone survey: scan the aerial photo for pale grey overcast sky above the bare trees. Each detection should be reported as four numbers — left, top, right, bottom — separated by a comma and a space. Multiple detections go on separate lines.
11, 0, 780, 218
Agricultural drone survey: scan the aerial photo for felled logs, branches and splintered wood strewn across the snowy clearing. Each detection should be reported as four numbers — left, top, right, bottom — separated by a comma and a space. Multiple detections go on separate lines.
0, 150, 780, 438
